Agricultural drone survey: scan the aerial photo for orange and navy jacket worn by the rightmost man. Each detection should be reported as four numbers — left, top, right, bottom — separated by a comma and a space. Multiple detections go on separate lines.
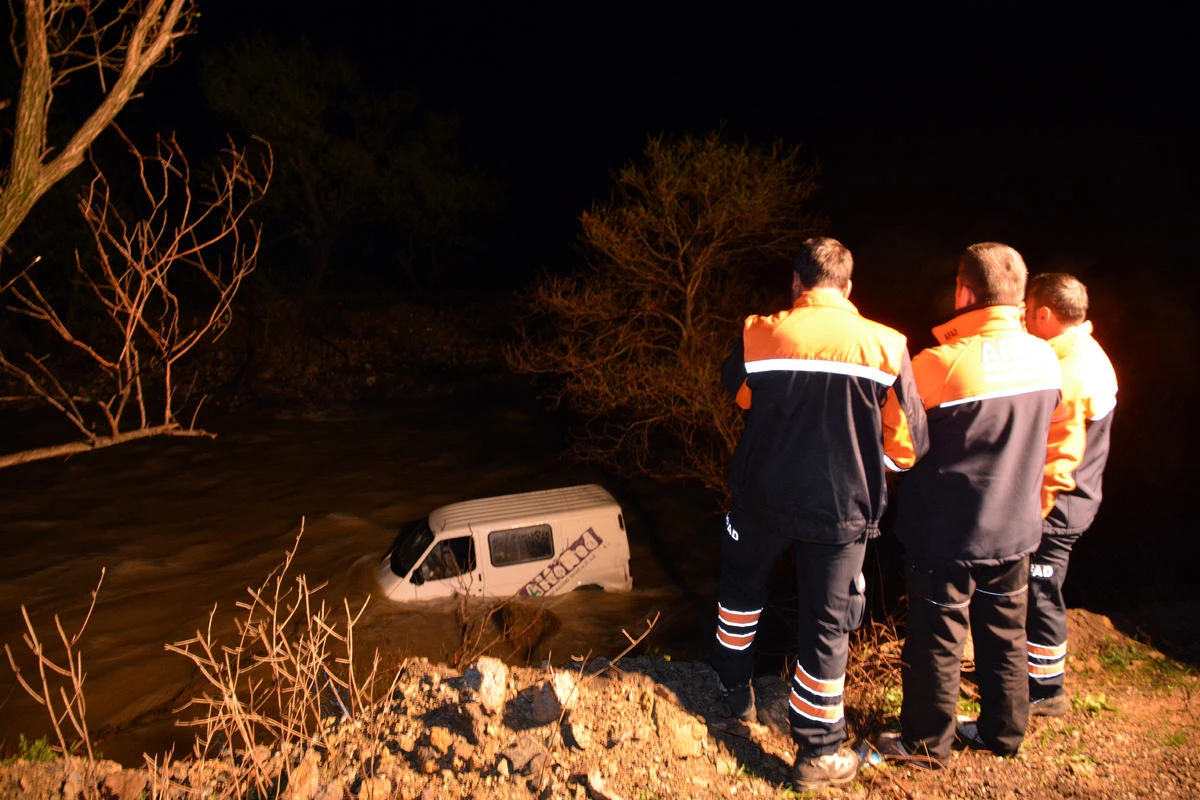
1042, 321, 1117, 534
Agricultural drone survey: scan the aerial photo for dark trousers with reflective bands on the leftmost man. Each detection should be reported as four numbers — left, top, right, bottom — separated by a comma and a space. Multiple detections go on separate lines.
713, 511, 866, 756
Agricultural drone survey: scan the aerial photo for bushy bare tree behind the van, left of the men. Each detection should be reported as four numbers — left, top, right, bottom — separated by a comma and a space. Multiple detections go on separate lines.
509, 133, 820, 495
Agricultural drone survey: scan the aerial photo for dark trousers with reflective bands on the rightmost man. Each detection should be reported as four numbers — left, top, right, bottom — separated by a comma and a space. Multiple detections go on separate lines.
1025, 534, 1079, 700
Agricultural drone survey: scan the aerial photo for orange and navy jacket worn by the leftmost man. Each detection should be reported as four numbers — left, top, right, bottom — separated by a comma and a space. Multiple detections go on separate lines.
722, 290, 928, 545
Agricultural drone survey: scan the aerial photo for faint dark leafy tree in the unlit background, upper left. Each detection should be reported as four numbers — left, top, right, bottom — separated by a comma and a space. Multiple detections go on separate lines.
204, 38, 491, 297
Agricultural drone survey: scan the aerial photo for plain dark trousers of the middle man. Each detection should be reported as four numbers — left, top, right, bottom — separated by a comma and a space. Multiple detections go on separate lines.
900, 557, 1030, 762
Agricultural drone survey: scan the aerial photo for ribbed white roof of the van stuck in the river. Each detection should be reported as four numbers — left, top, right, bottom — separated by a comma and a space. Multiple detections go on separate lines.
430, 483, 617, 534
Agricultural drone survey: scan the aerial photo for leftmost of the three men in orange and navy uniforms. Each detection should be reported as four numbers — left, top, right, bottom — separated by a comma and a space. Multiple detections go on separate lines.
713, 237, 928, 789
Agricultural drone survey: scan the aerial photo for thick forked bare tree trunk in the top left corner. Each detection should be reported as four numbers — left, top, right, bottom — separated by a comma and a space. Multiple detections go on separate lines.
0, 0, 196, 253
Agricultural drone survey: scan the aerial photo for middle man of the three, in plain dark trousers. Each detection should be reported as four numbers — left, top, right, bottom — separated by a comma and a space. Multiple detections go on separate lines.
878, 242, 1070, 766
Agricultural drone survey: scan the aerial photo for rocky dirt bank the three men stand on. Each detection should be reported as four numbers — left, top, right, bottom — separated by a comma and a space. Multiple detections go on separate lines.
0, 610, 1200, 800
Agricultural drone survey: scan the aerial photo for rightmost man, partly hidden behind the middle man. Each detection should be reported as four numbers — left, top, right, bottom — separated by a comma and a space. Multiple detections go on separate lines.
1025, 272, 1117, 716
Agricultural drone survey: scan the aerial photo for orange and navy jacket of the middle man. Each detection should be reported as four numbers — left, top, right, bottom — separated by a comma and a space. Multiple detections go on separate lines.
895, 306, 1072, 565
